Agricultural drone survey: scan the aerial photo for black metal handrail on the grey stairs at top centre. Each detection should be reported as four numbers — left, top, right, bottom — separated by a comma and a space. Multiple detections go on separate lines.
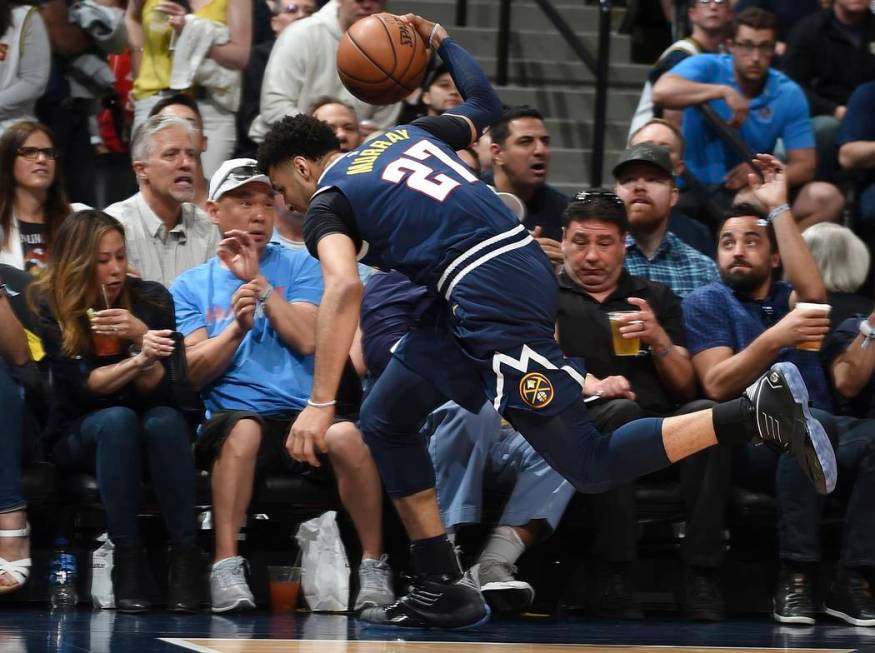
482, 0, 613, 186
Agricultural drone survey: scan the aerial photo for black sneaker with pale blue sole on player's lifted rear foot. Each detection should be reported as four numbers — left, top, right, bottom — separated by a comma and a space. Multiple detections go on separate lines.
744, 362, 838, 494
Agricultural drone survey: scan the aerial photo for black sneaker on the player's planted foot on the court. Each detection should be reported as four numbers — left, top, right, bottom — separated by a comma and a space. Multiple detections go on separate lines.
359, 571, 491, 630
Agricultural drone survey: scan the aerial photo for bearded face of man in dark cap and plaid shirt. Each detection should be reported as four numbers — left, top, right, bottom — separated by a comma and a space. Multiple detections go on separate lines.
616, 163, 678, 233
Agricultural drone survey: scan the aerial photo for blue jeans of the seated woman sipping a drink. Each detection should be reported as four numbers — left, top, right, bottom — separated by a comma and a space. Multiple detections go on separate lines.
55, 406, 195, 545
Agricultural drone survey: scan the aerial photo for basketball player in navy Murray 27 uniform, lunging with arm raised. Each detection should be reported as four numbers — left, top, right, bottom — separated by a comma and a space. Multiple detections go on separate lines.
259, 15, 836, 628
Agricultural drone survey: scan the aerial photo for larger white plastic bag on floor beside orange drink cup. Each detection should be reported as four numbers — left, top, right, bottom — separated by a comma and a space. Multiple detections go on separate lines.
295, 510, 349, 612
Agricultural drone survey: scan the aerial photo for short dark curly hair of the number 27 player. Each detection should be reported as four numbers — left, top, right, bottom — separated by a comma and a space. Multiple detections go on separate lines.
258, 113, 340, 174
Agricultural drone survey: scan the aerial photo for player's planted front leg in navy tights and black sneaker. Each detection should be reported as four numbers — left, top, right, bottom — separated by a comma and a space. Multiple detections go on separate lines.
360, 358, 489, 628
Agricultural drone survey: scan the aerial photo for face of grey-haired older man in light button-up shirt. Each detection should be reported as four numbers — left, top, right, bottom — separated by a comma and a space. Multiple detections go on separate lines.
134, 127, 197, 203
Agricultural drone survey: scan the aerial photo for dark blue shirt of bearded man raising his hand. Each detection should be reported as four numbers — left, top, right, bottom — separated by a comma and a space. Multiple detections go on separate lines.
684, 281, 833, 412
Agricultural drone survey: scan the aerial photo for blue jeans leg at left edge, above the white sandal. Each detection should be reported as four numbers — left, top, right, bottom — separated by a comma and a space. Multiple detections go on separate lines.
0, 360, 27, 513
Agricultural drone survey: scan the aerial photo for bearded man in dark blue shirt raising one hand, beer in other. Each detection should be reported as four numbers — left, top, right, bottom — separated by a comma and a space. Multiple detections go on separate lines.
683, 155, 875, 625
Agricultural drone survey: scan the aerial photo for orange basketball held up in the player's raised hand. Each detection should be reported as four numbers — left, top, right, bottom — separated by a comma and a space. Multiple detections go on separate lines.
337, 13, 428, 104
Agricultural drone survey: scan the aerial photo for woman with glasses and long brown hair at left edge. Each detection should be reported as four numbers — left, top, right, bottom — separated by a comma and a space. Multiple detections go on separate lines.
0, 120, 70, 273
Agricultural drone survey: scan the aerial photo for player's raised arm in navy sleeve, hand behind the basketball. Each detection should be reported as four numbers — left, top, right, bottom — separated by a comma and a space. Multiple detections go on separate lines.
403, 14, 501, 150
